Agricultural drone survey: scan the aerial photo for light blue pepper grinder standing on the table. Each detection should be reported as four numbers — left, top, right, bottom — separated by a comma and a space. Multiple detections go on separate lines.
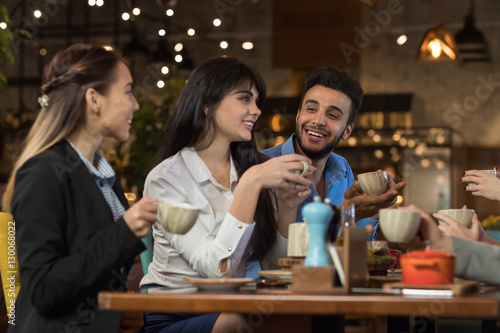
302, 196, 334, 267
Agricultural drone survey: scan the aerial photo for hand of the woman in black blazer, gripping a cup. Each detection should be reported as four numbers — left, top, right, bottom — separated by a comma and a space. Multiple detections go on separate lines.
123, 197, 157, 238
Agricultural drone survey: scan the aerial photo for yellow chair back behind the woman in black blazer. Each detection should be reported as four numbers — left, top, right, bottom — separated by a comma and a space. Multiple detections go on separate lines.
0, 212, 21, 320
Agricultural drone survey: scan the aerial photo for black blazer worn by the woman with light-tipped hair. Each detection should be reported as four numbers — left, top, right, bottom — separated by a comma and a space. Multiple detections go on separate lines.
9, 140, 145, 333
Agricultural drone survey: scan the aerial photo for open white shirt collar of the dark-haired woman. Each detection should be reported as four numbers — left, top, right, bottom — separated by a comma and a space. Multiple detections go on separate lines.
180, 147, 238, 192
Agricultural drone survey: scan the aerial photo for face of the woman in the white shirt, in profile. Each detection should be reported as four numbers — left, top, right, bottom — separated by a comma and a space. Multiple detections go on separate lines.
214, 85, 261, 143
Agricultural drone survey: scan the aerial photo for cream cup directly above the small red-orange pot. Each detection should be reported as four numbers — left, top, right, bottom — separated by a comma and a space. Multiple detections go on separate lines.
379, 208, 420, 243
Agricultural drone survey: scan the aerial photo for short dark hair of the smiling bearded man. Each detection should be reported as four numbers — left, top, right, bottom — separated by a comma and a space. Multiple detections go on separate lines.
299, 66, 363, 125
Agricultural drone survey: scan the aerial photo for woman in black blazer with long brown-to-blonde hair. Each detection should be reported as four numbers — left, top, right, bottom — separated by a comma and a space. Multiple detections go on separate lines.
3, 44, 156, 333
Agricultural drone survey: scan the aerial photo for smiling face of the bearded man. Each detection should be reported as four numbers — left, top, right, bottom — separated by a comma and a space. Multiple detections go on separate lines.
295, 86, 352, 160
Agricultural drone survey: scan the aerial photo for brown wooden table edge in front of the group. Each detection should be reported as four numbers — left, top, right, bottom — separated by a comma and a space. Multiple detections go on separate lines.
99, 291, 500, 332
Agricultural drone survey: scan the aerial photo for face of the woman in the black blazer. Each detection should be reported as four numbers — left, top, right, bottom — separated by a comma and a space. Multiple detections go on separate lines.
99, 62, 139, 141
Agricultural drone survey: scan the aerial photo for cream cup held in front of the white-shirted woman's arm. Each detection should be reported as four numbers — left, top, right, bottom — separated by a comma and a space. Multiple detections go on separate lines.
157, 201, 200, 235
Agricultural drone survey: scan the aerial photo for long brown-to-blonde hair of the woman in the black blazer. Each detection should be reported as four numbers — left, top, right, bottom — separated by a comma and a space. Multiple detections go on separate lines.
3, 44, 125, 211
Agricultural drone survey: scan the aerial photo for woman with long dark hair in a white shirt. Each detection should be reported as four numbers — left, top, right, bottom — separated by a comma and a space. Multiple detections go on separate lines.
141, 57, 310, 332
